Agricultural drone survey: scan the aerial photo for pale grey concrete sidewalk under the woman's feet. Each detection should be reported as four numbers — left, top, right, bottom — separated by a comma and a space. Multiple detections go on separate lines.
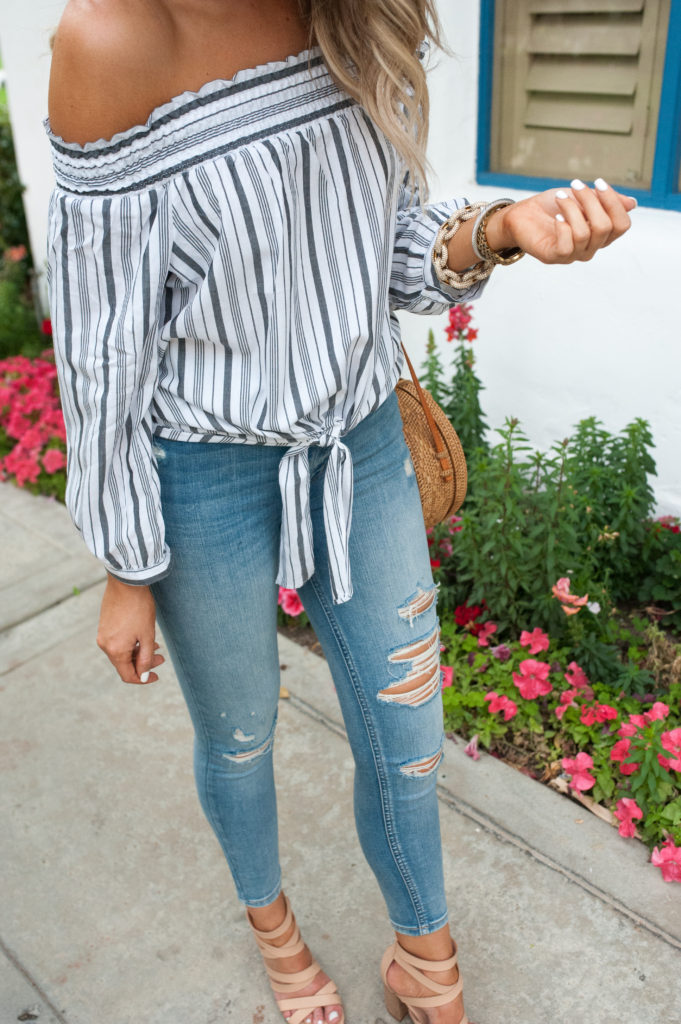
0, 484, 681, 1024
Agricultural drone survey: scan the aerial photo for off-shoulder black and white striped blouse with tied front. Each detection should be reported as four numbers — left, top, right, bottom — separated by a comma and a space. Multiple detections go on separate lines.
45, 47, 480, 602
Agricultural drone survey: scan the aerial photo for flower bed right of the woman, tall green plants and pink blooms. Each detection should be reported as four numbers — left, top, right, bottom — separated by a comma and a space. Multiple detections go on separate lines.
422, 306, 681, 881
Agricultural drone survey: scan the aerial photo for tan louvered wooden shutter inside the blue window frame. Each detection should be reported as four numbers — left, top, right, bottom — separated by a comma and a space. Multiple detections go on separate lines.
491, 0, 671, 187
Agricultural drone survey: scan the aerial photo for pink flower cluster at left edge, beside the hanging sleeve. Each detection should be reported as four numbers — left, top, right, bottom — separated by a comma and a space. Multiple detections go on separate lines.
0, 350, 67, 501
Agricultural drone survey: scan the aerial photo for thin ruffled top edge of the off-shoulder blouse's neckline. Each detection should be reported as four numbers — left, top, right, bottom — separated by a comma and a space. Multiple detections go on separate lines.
43, 45, 322, 153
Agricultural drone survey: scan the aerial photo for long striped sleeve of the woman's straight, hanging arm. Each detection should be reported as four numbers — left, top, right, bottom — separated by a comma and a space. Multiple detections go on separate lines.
47, 187, 170, 585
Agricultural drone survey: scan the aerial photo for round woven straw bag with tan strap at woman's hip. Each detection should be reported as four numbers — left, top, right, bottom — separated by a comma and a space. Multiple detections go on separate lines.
395, 345, 468, 528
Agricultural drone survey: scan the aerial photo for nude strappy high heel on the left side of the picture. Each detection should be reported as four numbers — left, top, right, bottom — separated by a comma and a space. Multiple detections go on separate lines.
247, 895, 345, 1024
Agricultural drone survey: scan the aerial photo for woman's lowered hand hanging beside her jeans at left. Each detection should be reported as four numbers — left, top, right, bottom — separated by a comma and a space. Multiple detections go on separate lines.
97, 575, 165, 683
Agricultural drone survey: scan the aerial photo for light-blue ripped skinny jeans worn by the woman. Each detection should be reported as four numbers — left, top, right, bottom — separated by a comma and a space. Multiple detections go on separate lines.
152, 393, 448, 935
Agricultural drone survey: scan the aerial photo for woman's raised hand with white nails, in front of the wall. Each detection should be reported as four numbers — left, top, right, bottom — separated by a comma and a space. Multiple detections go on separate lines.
486, 178, 637, 263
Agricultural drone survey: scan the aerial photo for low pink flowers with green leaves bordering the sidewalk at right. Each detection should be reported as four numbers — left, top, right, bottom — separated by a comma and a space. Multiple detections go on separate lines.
441, 588, 681, 881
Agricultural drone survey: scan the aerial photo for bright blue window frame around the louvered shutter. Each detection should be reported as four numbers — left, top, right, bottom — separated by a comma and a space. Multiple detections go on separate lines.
476, 0, 681, 210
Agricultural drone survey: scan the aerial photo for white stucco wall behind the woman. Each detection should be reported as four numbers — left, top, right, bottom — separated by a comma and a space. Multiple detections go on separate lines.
0, 0, 681, 513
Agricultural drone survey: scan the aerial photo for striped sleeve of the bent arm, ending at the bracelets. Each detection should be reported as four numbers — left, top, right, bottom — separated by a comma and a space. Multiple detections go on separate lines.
389, 174, 486, 313
